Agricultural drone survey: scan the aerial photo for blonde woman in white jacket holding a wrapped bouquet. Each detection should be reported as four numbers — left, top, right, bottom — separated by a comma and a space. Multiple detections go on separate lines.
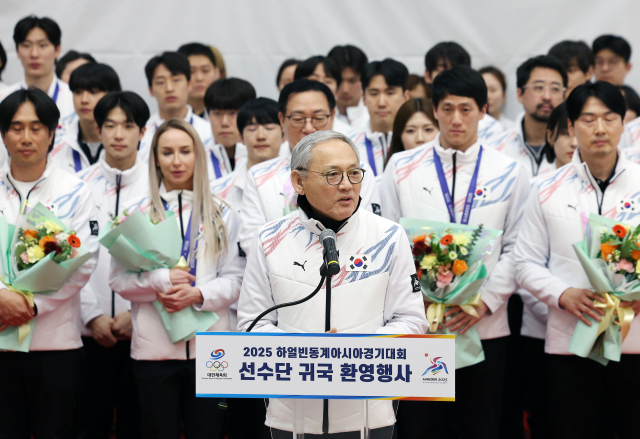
109, 119, 245, 439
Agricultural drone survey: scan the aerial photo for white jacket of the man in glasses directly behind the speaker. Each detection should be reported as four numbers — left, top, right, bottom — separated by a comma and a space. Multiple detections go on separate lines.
240, 157, 380, 254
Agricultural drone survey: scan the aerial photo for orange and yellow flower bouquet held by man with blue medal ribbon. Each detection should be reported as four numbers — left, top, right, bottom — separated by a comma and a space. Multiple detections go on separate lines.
400, 218, 502, 369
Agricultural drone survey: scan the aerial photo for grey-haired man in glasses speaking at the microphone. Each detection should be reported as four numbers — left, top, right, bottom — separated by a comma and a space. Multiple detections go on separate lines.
238, 131, 428, 439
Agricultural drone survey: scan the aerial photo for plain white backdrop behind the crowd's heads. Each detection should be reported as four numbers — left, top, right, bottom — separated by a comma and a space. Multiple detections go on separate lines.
0, 0, 640, 117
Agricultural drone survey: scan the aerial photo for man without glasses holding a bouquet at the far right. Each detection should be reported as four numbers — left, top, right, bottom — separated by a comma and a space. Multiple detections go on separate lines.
515, 82, 640, 438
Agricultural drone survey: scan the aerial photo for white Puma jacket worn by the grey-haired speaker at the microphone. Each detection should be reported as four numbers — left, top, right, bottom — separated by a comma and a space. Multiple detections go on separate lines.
238, 209, 427, 434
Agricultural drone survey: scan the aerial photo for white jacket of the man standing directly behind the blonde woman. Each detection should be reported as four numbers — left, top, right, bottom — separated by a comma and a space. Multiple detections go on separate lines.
138, 105, 231, 182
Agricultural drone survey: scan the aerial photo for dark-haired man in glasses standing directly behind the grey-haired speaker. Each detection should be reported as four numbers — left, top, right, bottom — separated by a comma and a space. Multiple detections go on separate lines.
240, 79, 380, 254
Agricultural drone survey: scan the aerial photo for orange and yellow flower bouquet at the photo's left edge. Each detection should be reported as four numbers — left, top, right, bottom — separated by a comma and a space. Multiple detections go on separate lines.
0, 203, 91, 352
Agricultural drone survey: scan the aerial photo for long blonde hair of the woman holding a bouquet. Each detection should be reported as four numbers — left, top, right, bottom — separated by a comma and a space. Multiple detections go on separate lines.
149, 119, 227, 259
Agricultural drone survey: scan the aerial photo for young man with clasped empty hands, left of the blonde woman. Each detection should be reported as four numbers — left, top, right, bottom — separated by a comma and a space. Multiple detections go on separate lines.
72, 91, 150, 437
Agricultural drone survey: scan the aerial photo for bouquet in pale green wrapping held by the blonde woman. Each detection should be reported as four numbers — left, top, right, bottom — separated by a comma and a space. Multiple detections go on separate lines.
98, 210, 219, 343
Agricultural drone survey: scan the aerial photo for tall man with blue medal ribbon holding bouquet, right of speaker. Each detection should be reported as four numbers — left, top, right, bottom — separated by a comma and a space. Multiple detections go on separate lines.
380, 67, 529, 437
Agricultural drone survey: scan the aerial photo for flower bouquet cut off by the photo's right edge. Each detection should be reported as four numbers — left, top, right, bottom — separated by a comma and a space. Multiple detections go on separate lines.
569, 214, 640, 364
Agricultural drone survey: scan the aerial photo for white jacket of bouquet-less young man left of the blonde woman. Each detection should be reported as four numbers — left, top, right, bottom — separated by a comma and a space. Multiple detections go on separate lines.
78, 158, 150, 336
